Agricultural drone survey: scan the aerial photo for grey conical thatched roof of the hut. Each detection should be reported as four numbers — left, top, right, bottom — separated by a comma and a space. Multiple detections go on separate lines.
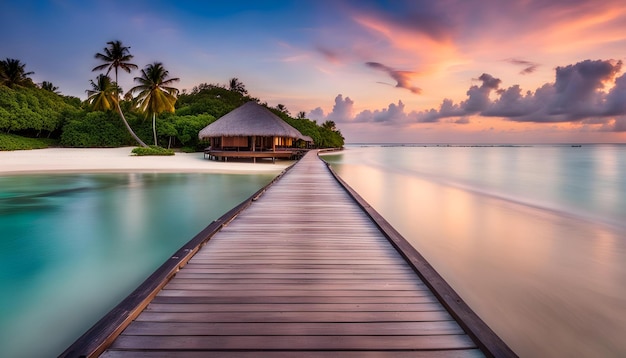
198, 102, 310, 139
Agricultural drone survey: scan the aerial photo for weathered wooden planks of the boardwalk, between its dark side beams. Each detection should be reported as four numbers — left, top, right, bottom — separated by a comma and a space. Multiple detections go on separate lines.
66, 152, 512, 358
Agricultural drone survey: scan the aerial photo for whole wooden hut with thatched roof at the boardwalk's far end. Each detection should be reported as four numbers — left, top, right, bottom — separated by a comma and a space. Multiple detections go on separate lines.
198, 102, 313, 162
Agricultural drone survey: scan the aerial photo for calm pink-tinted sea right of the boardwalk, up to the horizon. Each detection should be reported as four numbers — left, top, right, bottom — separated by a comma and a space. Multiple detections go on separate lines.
325, 145, 626, 357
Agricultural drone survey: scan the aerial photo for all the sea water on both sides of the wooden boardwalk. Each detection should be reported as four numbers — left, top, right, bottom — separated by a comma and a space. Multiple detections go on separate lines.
0, 145, 626, 357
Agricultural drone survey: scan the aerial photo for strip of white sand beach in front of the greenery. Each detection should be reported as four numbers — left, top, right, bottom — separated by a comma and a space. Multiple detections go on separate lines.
0, 147, 293, 175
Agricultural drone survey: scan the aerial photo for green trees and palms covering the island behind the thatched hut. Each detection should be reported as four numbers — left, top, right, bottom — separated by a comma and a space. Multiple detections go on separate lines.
0, 41, 344, 151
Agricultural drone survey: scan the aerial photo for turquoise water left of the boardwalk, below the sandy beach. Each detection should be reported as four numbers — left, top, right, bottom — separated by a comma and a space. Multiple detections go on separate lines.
0, 173, 274, 357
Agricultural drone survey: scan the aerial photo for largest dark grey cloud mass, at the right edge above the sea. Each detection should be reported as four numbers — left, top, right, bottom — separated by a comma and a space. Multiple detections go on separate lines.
416, 60, 626, 124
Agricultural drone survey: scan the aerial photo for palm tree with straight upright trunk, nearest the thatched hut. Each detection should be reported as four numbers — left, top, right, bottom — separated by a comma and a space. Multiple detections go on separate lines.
130, 62, 180, 145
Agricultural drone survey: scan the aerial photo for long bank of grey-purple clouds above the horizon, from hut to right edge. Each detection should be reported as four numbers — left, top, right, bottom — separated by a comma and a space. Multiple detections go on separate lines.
309, 60, 626, 132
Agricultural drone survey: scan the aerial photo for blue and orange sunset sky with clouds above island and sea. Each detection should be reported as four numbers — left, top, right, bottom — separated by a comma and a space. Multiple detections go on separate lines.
0, 0, 626, 144
